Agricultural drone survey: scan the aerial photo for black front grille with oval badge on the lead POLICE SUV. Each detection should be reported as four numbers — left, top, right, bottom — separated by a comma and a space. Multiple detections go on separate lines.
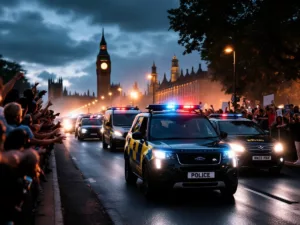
177, 152, 221, 165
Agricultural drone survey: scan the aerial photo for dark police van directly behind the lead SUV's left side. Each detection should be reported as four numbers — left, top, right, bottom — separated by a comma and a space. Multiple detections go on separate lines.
101, 106, 140, 150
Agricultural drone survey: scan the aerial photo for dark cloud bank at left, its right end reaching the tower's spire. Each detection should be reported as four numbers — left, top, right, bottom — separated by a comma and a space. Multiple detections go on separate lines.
0, 12, 100, 66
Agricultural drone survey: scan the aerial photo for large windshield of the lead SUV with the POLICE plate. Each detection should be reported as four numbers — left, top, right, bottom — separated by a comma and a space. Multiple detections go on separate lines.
150, 115, 218, 140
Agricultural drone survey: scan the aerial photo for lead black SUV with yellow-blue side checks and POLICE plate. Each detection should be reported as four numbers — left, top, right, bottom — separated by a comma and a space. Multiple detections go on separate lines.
124, 105, 238, 196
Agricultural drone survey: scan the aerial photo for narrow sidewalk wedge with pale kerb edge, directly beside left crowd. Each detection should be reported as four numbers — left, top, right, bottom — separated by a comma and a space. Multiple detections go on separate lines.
35, 150, 63, 225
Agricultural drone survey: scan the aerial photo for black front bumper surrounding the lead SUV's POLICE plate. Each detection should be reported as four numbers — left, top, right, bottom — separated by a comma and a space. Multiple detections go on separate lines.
151, 162, 238, 189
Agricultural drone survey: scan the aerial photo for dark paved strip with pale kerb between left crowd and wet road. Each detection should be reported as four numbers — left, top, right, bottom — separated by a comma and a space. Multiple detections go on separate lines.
35, 144, 113, 225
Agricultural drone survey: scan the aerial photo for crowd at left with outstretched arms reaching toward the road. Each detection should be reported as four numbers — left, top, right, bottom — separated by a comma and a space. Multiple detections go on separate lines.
0, 73, 65, 225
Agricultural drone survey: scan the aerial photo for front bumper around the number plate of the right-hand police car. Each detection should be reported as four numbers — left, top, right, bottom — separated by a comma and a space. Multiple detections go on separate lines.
238, 152, 284, 169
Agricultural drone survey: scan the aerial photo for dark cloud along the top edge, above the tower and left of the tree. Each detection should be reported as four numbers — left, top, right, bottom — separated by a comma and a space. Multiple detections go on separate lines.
39, 0, 178, 32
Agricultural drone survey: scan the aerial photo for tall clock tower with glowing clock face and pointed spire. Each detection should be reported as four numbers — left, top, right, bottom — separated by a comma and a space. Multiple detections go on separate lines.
96, 29, 111, 100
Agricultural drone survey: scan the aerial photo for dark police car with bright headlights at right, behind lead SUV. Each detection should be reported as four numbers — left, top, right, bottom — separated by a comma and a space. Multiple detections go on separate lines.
210, 114, 284, 175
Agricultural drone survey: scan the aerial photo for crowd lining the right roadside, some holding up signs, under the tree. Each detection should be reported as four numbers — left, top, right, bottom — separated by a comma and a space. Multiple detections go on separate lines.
199, 102, 300, 165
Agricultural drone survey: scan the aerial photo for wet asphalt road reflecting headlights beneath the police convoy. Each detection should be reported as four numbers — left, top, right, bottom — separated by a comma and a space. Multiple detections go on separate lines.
65, 135, 300, 225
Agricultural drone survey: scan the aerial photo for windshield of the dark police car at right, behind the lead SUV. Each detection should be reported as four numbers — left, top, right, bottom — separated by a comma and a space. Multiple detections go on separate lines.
219, 121, 264, 135
